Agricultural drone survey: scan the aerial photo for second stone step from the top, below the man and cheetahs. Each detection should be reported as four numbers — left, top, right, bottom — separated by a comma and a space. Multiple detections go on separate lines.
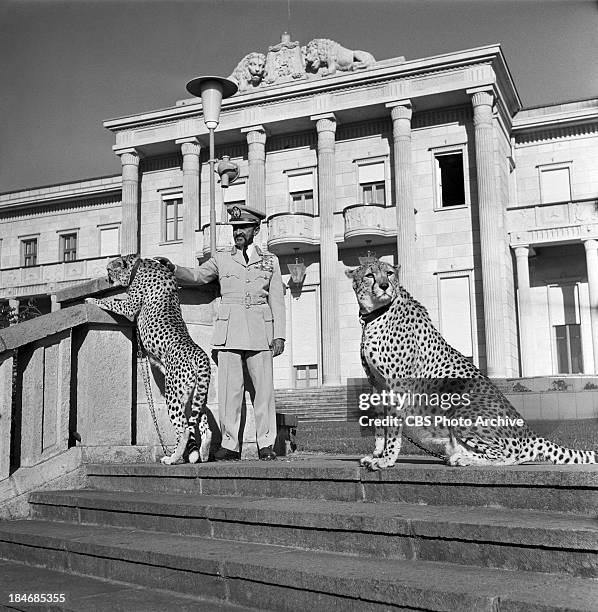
29, 490, 598, 578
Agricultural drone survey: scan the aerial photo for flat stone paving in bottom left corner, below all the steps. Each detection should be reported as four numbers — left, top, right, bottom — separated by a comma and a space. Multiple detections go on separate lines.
0, 560, 257, 612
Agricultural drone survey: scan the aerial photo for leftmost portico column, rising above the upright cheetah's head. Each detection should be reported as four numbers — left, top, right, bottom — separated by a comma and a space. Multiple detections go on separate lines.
119, 149, 140, 255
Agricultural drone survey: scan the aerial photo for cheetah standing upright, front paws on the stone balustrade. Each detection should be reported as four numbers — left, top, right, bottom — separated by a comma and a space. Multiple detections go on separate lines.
85, 255, 212, 465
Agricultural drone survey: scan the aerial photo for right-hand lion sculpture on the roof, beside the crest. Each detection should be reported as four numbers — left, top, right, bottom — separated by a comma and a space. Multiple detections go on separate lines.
301, 38, 376, 76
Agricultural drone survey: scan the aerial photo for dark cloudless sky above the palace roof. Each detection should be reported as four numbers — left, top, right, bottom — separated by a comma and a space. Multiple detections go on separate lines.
0, 0, 598, 192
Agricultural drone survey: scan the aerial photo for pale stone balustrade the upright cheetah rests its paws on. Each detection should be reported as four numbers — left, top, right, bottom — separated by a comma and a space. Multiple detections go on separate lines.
0, 305, 138, 516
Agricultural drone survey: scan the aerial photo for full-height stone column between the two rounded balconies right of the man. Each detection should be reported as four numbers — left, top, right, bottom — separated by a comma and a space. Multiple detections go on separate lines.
311, 114, 340, 385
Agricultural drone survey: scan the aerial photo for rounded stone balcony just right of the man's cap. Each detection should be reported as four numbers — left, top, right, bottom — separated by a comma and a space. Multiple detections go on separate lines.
268, 213, 320, 255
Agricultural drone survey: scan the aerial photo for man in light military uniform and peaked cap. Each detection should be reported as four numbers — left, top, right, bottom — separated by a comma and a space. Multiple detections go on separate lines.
160, 206, 286, 461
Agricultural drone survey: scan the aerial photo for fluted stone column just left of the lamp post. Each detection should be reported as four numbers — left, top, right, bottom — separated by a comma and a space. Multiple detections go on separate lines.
176, 138, 201, 267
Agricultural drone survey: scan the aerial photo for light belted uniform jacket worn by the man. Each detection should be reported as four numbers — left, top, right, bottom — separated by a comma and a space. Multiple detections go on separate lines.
175, 246, 286, 351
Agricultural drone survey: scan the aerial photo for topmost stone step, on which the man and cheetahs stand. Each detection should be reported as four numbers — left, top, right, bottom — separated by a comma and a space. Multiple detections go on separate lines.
88, 456, 598, 515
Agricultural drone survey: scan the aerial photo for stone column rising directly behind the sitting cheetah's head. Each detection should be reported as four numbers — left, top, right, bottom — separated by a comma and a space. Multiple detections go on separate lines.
386, 100, 418, 296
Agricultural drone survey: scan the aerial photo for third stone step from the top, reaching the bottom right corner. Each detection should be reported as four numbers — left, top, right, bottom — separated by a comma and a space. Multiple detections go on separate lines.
0, 520, 598, 612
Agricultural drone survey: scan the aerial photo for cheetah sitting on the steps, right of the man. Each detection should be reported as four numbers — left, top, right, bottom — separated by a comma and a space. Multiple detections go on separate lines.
346, 260, 596, 470
